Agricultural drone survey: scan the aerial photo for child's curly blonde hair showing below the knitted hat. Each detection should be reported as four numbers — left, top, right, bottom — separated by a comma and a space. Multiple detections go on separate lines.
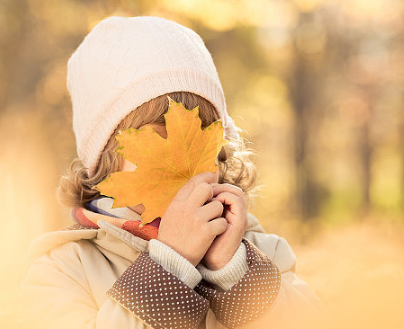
57, 92, 256, 207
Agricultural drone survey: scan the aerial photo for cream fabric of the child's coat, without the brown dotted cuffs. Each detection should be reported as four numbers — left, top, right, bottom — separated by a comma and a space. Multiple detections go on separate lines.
22, 215, 321, 329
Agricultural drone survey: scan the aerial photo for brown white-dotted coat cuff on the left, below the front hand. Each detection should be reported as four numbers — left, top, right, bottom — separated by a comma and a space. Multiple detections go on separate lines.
107, 252, 209, 329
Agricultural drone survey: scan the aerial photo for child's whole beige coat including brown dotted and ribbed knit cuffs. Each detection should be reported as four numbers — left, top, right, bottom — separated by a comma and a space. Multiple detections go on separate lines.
22, 215, 321, 329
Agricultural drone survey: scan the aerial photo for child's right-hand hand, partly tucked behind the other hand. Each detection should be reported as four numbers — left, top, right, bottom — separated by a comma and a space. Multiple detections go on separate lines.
202, 184, 248, 270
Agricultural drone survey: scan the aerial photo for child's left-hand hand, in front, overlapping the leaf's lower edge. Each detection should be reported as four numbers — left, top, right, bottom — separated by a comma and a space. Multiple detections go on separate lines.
157, 172, 227, 266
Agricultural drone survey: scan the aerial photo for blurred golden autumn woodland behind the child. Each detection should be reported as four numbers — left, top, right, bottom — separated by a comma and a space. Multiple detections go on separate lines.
0, 0, 404, 328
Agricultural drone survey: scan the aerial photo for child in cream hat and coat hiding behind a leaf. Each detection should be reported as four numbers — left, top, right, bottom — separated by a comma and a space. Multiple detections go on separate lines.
23, 17, 318, 329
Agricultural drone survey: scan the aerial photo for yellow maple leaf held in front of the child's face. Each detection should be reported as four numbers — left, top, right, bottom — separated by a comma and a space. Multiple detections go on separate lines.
97, 98, 228, 225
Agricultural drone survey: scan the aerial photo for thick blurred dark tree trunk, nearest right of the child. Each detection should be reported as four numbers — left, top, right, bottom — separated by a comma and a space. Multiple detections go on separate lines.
289, 12, 324, 221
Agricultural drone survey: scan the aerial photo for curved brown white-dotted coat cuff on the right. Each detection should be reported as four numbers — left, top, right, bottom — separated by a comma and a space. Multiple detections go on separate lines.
195, 237, 281, 328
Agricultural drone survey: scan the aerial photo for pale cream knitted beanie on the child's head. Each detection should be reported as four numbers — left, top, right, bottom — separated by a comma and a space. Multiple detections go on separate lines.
67, 16, 238, 177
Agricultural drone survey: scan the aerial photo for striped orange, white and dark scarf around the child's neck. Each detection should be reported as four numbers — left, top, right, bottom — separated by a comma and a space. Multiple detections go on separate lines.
72, 197, 161, 241
